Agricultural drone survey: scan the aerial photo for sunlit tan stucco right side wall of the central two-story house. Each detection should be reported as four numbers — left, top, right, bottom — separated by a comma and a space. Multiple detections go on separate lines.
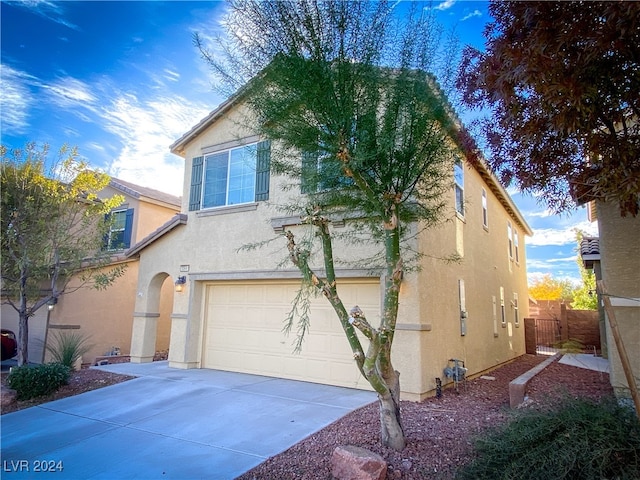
388, 160, 528, 399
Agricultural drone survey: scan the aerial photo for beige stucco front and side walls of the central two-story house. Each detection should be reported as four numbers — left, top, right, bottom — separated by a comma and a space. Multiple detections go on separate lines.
132, 103, 528, 400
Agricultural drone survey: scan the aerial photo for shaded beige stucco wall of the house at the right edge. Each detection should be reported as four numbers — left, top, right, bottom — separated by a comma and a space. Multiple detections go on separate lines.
596, 202, 640, 396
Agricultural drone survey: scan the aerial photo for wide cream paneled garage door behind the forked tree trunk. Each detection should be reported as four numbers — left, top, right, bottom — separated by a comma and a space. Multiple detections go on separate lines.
202, 279, 380, 388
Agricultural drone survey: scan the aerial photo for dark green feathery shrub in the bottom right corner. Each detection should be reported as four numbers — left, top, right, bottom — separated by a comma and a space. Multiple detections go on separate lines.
456, 399, 640, 480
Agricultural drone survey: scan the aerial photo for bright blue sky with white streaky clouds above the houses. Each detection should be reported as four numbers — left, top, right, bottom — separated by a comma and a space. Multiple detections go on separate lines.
0, 0, 596, 280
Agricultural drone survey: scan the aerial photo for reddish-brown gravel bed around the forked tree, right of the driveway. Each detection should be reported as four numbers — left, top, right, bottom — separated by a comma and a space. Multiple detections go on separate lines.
239, 355, 613, 480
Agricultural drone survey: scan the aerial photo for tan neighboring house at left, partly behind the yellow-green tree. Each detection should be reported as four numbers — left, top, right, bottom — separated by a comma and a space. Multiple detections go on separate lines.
2, 178, 181, 363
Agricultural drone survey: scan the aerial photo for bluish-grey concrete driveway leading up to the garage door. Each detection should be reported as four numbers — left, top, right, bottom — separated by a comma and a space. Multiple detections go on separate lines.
1, 362, 376, 480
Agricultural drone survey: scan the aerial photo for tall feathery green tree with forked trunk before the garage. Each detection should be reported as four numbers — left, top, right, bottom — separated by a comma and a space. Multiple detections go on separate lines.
195, 0, 464, 450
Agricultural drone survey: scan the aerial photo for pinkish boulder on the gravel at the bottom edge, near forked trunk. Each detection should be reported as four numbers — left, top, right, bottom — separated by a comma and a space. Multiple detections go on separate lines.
331, 445, 387, 480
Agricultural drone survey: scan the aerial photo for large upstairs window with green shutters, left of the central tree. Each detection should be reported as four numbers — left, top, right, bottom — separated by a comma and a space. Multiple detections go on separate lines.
189, 141, 270, 211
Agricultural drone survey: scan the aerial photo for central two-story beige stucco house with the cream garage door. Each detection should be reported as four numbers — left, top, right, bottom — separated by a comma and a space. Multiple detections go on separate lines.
127, 94, 532, 400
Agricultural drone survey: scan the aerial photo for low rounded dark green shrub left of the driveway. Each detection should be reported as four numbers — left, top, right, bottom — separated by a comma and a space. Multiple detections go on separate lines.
7, 363, 71, 400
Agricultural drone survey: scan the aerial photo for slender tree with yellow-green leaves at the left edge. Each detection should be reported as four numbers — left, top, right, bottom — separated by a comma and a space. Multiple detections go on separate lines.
0, 143, 123, 365
